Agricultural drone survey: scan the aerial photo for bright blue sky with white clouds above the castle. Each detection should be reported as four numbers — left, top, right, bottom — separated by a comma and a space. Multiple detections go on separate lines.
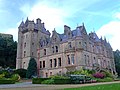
0, 0, 120, 50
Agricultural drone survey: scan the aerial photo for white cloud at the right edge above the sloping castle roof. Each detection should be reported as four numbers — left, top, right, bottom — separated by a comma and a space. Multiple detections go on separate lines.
97, 21, 120, 50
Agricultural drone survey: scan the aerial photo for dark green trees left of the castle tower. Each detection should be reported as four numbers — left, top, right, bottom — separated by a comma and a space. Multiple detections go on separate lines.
0, 34, 17, 68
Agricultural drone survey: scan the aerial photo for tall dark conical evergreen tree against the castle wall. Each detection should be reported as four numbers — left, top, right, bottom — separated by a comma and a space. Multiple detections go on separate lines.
26, 58, 37, 78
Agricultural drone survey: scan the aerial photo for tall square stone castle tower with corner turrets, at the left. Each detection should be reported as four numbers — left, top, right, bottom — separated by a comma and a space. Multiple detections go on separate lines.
16, 18, 50, 69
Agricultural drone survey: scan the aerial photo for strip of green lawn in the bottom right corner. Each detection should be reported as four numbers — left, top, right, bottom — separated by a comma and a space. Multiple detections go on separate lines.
64, 83, 120, 90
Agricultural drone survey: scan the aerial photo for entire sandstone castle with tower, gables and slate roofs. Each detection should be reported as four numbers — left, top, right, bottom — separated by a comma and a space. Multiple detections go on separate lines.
16, 18, 116, 77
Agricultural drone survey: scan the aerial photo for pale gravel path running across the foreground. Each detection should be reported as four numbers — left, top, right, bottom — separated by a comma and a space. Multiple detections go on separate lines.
0, 81, 120, 90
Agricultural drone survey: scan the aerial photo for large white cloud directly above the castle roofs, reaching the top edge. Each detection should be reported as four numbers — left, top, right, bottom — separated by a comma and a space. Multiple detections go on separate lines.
20, 0, 99, 32
